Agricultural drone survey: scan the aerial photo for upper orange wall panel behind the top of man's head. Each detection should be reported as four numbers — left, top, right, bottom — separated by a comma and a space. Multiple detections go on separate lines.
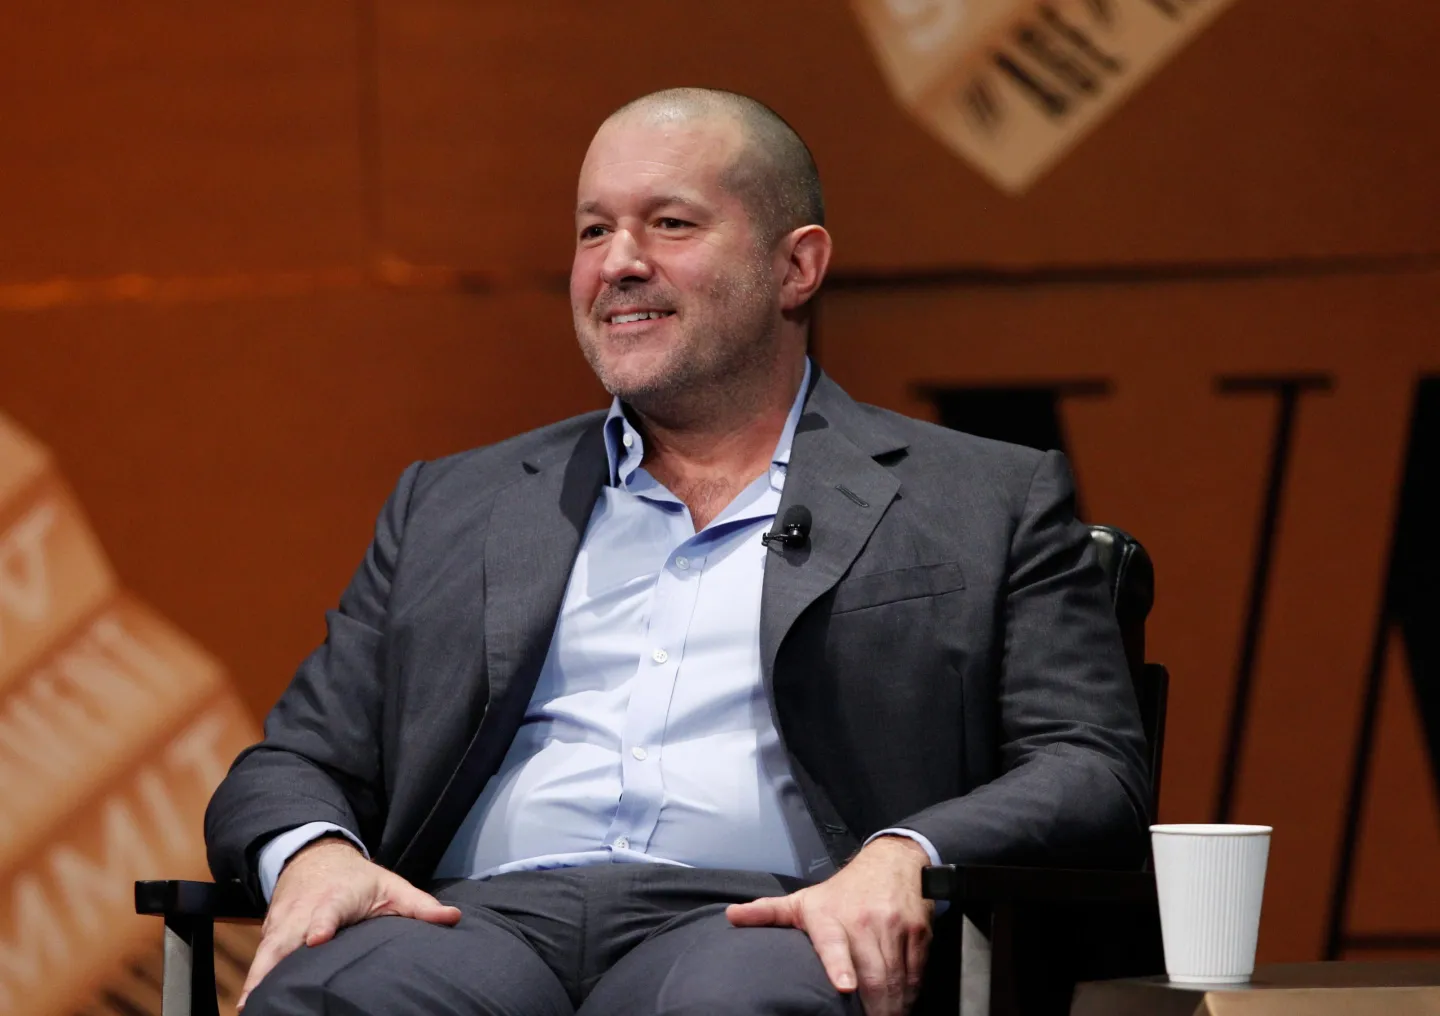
379, 0, 1440, 273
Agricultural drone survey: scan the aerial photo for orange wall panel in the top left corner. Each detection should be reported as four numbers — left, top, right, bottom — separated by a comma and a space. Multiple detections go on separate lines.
0, 0, 364, 282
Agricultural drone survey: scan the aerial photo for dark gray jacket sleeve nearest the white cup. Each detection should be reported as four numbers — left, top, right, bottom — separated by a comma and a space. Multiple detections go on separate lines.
894, 452, 1149, 865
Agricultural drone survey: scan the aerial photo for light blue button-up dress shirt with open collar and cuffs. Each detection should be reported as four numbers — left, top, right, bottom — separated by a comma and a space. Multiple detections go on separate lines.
259, 361, 939, 898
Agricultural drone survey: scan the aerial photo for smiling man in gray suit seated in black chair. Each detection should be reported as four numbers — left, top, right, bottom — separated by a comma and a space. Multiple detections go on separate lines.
206, 89, 1148, 1016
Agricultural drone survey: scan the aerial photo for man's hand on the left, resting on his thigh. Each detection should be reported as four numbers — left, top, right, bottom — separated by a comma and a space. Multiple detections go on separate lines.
236, 836, 459, 1009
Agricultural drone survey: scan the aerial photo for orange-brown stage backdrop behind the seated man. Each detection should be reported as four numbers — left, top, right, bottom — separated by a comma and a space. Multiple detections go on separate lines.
0, 0, 1440, 978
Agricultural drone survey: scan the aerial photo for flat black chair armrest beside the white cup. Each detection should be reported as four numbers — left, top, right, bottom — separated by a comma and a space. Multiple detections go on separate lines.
920, 865, 1156, 904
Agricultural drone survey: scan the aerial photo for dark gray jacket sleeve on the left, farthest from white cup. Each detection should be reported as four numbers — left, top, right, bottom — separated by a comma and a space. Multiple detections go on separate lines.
204, 463, 422, 898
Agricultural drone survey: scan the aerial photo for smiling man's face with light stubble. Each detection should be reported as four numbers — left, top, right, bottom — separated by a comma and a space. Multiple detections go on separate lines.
570, 117, 780, 400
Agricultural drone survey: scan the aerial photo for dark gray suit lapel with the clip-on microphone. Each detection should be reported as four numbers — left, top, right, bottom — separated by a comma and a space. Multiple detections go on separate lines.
760, 374, 904, 687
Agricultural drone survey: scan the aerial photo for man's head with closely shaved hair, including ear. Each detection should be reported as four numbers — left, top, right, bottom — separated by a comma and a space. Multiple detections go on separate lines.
570, 88, 829, 410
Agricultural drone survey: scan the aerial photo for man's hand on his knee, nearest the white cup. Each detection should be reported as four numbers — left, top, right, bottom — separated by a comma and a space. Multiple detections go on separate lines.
726, 836, 935, 1016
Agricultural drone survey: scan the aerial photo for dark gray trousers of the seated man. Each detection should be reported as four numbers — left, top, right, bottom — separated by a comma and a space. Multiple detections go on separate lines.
245, 863, 861, 1016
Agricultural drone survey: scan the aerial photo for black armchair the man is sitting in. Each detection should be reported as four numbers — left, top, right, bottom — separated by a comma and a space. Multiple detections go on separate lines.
135, 525, 1169, 1016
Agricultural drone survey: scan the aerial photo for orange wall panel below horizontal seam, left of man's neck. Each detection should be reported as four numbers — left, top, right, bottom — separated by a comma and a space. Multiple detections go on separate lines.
0, 289, 605, 714
